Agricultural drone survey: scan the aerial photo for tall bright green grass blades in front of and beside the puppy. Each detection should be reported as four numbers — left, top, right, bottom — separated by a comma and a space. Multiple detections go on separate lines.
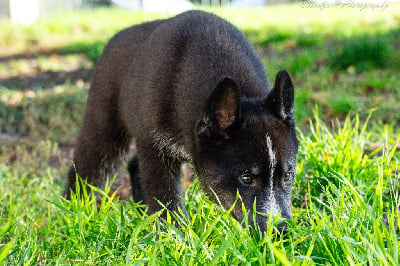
0, 112, 400, 265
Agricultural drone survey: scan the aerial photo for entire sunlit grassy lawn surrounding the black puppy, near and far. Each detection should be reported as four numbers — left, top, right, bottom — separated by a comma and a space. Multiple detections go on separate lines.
0, 4, 400, 265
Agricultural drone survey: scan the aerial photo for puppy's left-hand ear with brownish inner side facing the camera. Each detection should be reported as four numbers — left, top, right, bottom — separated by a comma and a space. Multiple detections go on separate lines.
196, 77, 241, 139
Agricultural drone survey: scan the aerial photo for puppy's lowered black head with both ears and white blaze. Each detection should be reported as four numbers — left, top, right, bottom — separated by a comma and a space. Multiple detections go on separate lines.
193, 70, 298, 230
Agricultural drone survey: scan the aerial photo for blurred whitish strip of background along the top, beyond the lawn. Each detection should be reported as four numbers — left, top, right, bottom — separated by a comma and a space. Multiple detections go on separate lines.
0, 0, 398, 24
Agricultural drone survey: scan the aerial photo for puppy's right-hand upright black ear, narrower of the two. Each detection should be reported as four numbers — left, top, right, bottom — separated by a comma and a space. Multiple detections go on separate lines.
264, 70, 294, 125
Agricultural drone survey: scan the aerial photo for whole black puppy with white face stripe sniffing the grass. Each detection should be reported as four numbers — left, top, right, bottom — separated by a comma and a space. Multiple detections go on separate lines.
67, 11, 298, 229
